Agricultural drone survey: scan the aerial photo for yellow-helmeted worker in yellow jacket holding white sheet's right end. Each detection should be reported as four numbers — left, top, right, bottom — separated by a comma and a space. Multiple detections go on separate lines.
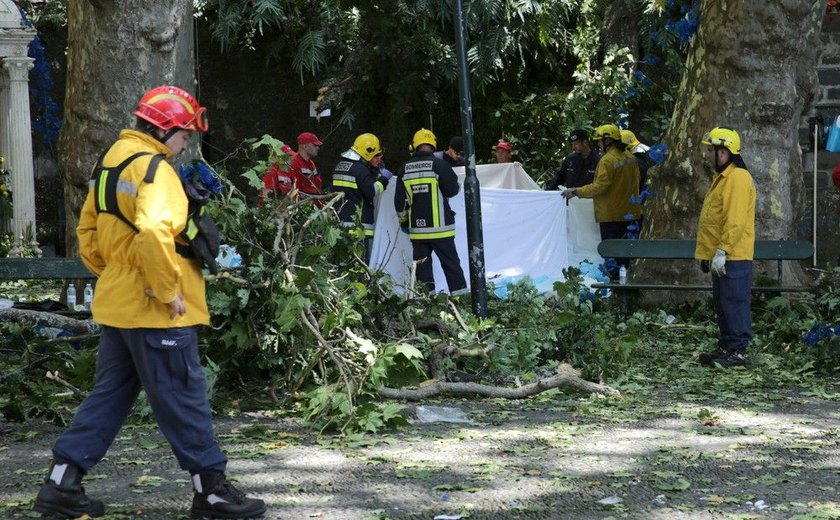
563, 124, 642, 278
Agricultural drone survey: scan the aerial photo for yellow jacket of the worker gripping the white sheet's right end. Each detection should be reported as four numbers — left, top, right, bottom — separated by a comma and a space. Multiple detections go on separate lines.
575, 146, 642, 222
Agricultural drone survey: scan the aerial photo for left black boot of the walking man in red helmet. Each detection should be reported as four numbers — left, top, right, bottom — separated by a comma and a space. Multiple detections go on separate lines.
33, 462, 105, 518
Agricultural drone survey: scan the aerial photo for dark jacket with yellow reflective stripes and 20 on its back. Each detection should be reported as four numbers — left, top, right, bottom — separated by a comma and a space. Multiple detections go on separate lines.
394, 152, 460, 240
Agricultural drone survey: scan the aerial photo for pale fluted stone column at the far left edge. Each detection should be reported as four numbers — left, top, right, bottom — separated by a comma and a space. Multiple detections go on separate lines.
3, 56, 41, 256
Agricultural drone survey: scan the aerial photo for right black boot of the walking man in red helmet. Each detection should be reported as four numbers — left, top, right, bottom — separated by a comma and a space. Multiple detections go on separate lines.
190, 471, 265, 518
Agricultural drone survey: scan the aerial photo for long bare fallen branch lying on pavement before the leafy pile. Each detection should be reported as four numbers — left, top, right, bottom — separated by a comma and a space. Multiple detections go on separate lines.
378, 365, 621, 401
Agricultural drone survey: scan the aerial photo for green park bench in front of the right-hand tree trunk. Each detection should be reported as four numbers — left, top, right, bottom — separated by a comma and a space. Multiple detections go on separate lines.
592, 239, 814, 313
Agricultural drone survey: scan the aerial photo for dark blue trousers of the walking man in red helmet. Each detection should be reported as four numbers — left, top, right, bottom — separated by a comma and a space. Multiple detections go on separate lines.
53, 327, 227, 473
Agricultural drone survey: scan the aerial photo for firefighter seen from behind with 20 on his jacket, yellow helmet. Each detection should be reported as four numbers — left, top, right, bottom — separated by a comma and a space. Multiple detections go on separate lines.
394, 128, 467, 295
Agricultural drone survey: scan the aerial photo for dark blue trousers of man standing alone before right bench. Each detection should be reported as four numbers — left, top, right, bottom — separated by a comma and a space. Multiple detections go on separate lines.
712, 260, 752, 353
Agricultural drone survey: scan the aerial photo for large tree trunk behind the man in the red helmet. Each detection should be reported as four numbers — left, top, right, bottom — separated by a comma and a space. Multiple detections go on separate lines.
58, 0, 195, 256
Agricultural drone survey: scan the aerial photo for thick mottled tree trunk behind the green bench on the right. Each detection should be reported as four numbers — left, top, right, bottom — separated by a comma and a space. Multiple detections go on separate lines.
637, 0, 824, 292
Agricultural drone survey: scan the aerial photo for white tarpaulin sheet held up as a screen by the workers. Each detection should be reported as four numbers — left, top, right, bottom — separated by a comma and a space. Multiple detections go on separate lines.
371, 163, 602, 291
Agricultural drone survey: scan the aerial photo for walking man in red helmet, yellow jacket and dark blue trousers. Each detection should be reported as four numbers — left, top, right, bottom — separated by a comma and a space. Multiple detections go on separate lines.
34, 86, 265, 518
